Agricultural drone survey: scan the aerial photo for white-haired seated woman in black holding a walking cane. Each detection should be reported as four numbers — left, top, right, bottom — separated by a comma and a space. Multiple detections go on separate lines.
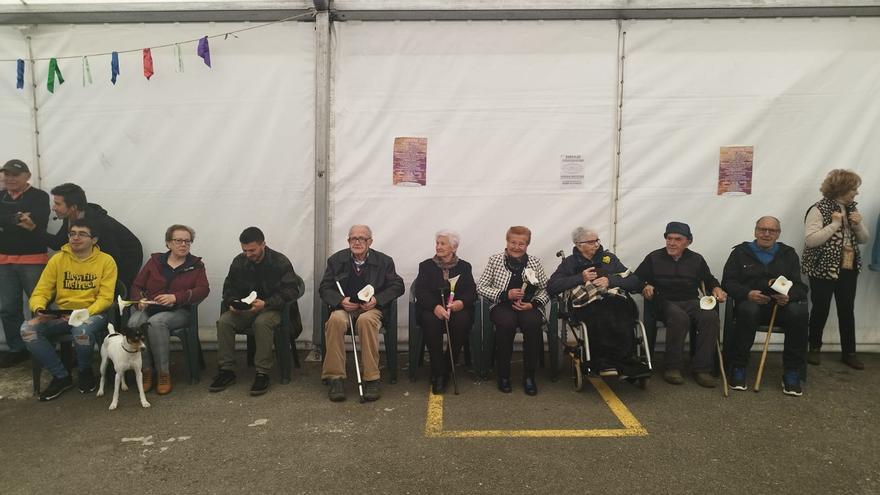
415, 230, 477, 394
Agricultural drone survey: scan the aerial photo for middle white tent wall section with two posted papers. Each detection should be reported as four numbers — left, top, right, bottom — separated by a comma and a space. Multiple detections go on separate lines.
330, 21, 618, 344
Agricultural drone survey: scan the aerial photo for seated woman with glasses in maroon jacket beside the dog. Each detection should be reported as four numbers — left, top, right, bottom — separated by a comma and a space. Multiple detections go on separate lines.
128, 225, 210, 395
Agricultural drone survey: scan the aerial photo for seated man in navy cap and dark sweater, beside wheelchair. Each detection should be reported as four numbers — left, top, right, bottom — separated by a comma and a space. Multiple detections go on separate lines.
635, 222, 727, 387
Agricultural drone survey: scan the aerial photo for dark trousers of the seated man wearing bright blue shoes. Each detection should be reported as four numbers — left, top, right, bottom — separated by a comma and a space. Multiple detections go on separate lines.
727, 300, 809, 370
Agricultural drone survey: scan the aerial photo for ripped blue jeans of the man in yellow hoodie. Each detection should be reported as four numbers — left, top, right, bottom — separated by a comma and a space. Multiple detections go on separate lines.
21, 313, 107, 378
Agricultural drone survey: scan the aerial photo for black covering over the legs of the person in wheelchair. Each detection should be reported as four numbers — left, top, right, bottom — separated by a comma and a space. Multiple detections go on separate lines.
573, 297, 635, 366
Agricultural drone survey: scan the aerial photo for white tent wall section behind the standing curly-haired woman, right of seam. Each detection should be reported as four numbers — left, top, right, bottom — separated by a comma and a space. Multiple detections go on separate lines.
618, 18, 880, 349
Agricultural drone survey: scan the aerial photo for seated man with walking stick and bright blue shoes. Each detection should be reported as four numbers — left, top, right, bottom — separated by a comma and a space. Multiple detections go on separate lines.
721, 216, 809, 396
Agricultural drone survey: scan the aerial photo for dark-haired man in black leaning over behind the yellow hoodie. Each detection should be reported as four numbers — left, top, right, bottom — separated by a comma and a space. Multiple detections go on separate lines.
19, 183, 144, 289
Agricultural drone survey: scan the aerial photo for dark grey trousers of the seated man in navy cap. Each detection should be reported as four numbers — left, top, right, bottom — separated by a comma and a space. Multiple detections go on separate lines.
663, 298, 721, 372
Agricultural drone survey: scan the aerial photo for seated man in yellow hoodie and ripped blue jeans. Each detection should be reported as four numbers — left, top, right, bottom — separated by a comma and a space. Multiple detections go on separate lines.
21, 218, 116, 401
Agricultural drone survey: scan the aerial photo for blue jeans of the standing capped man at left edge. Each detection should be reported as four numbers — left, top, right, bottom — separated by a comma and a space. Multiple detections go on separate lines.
0, 265, 46, 352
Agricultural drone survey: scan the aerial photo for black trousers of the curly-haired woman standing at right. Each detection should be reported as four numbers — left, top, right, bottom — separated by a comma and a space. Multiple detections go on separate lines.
810, 269, 859, 354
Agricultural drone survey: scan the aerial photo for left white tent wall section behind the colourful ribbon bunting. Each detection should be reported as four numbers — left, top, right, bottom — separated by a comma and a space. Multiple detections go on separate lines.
0, 22, 315, 348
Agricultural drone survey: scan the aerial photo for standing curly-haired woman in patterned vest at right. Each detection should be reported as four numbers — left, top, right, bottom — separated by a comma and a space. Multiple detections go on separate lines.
801, 169, 868, 370
